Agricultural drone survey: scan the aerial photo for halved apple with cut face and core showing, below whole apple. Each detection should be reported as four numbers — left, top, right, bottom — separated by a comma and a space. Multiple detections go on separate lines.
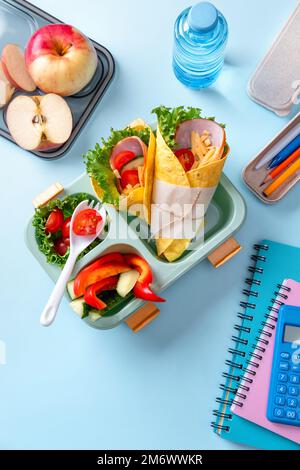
6, 93, 73, 151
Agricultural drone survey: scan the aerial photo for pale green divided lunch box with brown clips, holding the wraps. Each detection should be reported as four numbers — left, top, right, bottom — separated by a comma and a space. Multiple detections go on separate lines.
25, 174, 246, 332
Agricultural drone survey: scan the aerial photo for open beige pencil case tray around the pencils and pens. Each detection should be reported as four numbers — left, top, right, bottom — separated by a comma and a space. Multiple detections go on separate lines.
243, 113, 300, 204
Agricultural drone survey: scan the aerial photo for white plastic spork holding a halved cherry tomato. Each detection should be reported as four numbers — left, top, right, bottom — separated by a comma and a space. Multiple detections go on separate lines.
40, 201, 106, 326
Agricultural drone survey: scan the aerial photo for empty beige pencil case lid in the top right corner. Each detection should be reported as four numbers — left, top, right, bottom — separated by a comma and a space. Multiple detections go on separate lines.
248, 4, 300, 116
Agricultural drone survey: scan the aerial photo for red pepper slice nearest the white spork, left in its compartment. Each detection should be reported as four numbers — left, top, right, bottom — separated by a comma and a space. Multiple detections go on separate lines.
74, 252, 130, 297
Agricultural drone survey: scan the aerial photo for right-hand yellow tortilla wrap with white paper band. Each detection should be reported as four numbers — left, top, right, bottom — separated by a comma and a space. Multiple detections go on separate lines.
151, 106, 229, 262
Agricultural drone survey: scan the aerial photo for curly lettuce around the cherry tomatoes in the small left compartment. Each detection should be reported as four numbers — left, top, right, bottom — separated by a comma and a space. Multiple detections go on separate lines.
32, 193, 100, 268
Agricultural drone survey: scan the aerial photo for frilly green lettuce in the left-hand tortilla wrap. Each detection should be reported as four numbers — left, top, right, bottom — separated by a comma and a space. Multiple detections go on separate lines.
83, 127, 150, 205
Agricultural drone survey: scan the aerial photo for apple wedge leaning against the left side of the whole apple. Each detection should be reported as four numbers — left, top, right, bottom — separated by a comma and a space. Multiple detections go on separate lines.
1, 44, 36, 91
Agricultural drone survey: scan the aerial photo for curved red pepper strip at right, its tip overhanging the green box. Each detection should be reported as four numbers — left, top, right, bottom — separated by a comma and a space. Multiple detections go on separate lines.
124, 254, 165, 302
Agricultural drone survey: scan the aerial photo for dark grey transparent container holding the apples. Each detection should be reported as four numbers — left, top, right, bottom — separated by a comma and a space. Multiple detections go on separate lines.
0, 0, 115, 159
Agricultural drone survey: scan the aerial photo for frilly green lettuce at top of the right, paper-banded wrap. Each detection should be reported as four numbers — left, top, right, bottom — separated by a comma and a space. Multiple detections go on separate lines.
152, 106, 224, 150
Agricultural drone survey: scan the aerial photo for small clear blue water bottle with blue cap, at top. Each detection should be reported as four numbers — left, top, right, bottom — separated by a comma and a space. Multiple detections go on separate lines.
173, 2, 228, 89
